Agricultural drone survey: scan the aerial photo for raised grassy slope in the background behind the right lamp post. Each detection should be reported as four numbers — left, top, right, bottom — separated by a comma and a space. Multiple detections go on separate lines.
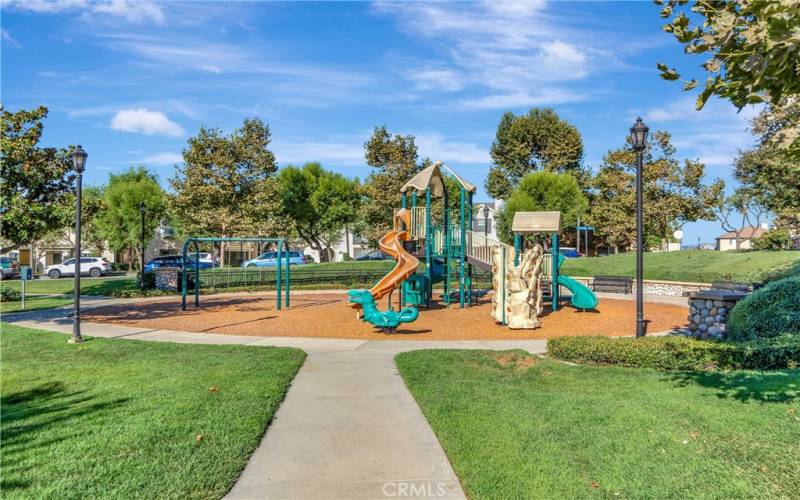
561, 250, 800, 283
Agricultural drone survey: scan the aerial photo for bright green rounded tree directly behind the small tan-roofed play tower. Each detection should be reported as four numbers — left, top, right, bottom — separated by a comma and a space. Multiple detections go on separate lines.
497, 172, 589, 243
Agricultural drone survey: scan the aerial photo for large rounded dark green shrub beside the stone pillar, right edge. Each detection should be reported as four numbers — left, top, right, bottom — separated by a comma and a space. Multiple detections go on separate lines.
727, 276, 800, 340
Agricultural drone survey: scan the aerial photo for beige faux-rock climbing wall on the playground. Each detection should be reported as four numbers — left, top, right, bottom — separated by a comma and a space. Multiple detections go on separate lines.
492, 245, 544, 329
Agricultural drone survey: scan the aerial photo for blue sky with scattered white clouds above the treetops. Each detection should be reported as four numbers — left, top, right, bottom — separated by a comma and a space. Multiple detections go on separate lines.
2, 0, 755, 244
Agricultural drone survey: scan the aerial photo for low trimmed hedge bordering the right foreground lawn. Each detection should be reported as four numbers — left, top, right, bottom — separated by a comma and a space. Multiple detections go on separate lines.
547, 335, 800, 371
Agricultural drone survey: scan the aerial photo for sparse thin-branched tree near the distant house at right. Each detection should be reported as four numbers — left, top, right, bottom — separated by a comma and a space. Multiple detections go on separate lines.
706, 179, 766, 250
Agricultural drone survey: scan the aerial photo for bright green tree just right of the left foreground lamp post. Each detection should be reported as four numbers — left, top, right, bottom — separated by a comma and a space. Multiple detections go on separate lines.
97, 167, 167, 270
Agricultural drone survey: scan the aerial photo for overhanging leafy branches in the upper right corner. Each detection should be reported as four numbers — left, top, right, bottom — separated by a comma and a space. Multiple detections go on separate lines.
656, 0, 800, 159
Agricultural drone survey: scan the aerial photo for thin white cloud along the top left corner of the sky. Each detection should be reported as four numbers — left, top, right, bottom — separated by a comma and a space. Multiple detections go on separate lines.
3, 0, 166, 24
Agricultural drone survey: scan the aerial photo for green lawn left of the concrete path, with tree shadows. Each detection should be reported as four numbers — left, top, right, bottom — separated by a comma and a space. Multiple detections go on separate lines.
0, 324, 305, 498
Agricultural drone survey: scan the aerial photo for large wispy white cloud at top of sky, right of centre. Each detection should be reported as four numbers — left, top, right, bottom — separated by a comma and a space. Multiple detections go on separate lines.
374, 1, 622, 109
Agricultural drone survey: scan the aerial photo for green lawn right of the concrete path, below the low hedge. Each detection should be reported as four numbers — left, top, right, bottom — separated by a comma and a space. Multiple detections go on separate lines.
397, 350, 800, 499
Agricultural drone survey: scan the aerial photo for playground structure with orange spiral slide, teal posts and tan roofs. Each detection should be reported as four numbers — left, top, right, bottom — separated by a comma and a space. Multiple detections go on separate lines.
351, 161, 597, 328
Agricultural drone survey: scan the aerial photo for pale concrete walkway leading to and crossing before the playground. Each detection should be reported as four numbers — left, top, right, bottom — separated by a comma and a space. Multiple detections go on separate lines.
2, 301, 546, 499
